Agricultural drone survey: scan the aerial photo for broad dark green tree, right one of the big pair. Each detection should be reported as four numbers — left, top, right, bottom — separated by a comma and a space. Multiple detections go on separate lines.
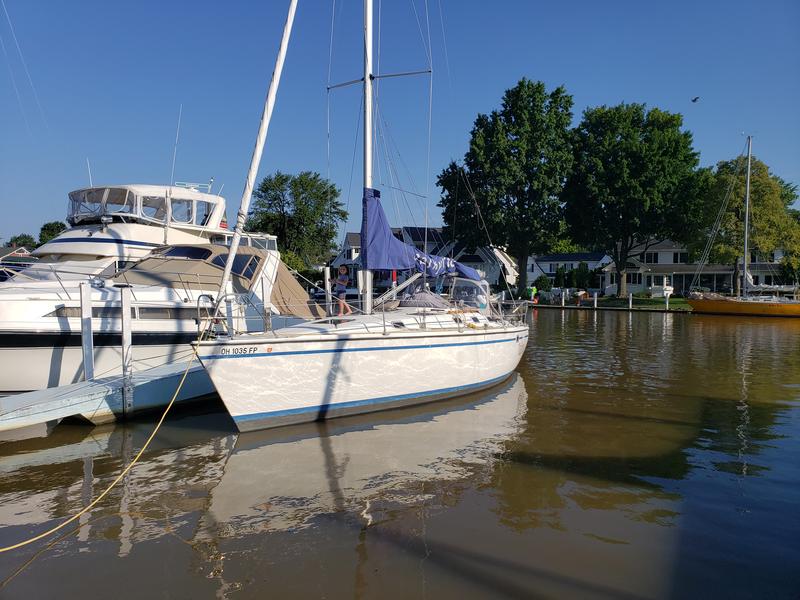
563, 104, 708, 296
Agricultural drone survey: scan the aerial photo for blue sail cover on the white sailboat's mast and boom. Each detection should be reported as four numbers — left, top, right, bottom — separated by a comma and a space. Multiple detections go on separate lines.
360, 188, 481, 281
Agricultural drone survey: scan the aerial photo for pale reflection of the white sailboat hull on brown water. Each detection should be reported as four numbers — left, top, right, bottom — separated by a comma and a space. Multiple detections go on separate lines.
200, 374, 527, 535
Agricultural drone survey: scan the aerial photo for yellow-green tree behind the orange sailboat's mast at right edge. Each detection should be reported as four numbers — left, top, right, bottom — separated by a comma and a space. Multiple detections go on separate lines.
696, 156, 800, 295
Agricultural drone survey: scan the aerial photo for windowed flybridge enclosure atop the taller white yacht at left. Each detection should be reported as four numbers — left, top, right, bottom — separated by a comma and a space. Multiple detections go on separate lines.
67, 185, 225, 228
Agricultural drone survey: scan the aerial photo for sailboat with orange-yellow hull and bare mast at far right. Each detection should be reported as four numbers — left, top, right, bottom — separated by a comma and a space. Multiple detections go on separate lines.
687, 136, 800, 317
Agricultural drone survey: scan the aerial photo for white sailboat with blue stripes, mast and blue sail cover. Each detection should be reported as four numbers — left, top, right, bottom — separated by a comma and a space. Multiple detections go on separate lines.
195, 0, 528, 431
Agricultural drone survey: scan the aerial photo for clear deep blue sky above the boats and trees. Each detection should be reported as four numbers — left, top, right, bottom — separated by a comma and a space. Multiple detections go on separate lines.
0, 0, 800, 242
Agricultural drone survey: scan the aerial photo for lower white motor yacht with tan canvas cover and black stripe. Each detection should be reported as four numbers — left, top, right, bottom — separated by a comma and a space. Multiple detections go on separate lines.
0, 244, 323, 394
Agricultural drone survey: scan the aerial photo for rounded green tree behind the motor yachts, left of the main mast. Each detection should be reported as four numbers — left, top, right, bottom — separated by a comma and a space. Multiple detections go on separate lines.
247, 171, 347, 265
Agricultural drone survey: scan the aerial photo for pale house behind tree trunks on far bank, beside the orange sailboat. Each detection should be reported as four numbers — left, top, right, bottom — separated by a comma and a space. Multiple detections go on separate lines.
603, 240, 783, 295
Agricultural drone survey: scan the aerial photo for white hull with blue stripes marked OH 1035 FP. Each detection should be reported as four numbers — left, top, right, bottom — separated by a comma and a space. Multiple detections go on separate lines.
198, 326, 528, 431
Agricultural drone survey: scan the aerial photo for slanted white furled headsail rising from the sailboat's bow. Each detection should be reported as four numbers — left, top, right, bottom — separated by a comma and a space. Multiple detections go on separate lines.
219, 0, 297, 308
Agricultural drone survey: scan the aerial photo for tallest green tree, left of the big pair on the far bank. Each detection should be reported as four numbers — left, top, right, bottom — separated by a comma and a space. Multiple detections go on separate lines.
437, 79, 572, 295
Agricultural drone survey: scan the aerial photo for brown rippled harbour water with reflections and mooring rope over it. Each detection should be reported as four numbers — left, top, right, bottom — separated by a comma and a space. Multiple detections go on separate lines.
0, 309, 800, 599
